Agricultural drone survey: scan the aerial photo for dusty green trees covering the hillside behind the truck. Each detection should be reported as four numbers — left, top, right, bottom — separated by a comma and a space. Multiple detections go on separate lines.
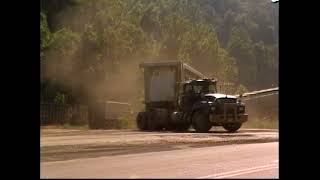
40, 0, 278, 109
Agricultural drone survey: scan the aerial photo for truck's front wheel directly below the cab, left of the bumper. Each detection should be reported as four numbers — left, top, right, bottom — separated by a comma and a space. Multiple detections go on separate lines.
192, 111, 212, 133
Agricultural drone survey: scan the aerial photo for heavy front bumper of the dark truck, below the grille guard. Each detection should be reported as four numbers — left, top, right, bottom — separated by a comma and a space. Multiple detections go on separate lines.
209, 114, 248, 124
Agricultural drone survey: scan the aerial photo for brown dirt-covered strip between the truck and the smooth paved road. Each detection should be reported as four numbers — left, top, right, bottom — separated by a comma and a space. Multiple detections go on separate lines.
40, 128, 278, 162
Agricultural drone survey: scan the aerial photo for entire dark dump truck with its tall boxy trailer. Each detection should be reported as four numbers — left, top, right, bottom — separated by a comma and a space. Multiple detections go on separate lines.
136, 61, 248, 133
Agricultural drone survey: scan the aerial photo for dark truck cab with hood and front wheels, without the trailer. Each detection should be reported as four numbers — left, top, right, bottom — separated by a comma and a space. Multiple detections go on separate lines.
179, 79, 248, 132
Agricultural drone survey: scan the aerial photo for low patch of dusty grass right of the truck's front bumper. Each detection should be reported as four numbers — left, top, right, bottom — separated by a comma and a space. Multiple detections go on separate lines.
242, 118, 279, 129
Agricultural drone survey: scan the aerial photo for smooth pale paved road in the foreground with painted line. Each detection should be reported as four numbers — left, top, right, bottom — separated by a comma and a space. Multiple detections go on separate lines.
41, 142, 278, 178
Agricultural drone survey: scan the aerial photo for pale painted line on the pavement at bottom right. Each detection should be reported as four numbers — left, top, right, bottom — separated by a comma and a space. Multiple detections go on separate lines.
198, 164, 277, 179
